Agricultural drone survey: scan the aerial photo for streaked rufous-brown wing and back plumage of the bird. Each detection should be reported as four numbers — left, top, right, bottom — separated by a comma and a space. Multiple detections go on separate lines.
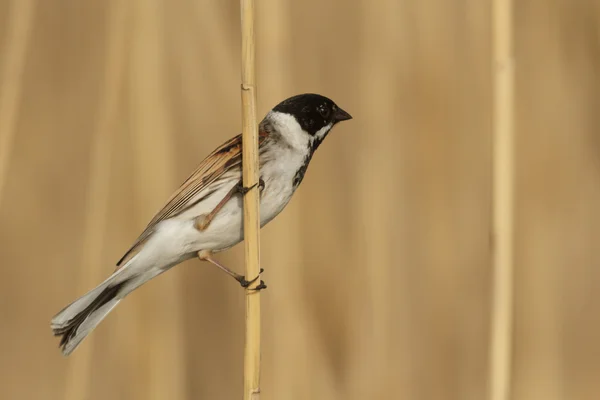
117, 132, 268, 267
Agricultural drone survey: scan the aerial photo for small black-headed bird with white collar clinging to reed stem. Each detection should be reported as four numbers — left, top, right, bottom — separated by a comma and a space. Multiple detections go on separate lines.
51, 93, 352, 356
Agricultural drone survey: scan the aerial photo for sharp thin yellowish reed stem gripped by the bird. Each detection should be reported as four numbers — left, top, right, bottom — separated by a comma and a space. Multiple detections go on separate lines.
240, 0, 260, 400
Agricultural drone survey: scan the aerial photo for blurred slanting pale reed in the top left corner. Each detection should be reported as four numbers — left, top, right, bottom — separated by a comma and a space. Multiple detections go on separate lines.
0, 0, 34, 209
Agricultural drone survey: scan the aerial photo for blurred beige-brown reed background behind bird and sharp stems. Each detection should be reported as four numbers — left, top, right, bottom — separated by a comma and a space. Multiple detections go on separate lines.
0, 0, 600, 400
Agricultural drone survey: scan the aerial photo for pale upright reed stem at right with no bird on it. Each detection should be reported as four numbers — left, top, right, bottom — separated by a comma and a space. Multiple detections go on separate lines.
489, 0, 514, 400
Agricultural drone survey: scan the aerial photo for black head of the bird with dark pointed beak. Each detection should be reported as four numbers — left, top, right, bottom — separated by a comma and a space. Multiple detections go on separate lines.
273, 93, 352, 136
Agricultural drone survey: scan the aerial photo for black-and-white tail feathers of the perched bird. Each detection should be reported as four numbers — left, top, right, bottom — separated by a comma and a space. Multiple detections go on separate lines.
51, 280, 128, 355
